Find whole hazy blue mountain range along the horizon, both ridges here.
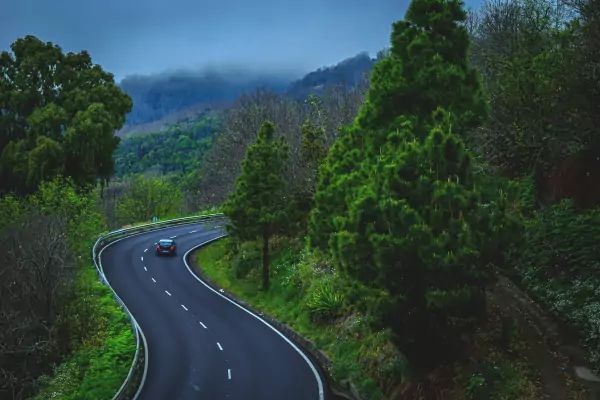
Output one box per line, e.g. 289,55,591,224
120,52,375,126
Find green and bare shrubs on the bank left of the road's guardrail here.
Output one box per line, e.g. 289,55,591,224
0,179,135,400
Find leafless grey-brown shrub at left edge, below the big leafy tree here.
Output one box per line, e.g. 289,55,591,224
0,215,74,399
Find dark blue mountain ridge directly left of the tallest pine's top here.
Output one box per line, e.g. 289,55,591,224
287,53,376,99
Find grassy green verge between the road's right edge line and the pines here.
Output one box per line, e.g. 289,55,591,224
194,239,384,400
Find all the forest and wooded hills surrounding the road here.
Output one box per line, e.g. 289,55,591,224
0,0,600,400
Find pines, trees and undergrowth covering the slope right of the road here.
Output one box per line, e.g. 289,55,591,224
209,0,600,399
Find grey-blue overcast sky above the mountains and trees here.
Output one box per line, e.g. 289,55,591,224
0,0,479,79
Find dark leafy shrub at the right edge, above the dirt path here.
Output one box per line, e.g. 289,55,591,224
510,201,600,365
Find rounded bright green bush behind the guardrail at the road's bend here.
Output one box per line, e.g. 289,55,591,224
115,175,183,224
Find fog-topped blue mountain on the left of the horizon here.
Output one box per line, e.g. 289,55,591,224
119,70,291,126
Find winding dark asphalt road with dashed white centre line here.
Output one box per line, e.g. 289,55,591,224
100,224,323,400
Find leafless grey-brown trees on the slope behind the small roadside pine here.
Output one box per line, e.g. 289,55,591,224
194,84,366,207
